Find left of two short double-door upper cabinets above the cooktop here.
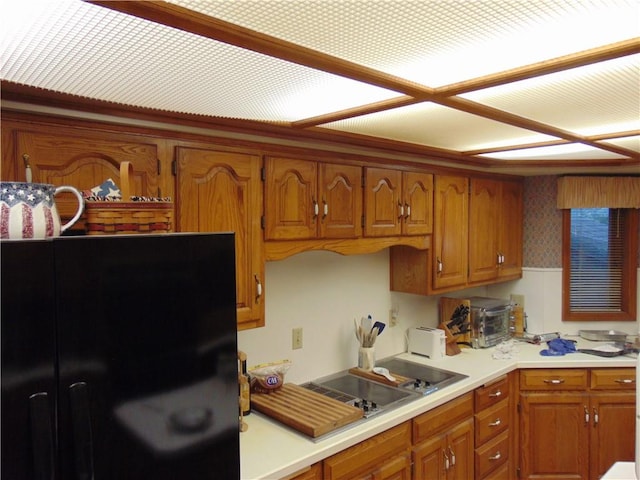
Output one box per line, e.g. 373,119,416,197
264,157,362,240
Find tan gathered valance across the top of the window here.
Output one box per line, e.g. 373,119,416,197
557,176,640,208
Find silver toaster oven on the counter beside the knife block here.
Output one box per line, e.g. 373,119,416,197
469,297,513,348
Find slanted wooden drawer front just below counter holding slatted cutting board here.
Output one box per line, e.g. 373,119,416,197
323,422,411,480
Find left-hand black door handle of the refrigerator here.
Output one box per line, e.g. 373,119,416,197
29,392,54,480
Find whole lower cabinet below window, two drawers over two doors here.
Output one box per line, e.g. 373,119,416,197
519,368,635,480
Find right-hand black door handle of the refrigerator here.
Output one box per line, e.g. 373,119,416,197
69,382,94,480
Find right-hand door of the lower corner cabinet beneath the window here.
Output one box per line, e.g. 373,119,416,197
591,392,636,479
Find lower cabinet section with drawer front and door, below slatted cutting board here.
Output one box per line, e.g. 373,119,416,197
323,422,411,480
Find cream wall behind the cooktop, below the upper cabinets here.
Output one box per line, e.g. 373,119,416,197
238,250,486,383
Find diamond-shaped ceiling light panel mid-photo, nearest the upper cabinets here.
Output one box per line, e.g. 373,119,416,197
321,103,555,151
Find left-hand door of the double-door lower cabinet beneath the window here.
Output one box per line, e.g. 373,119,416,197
520,391,590,480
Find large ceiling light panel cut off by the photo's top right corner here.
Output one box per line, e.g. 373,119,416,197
170,0,640,87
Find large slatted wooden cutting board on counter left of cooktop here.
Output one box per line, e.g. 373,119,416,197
251,383,363,438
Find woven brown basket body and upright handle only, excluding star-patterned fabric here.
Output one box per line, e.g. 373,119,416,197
85,162,173,235
